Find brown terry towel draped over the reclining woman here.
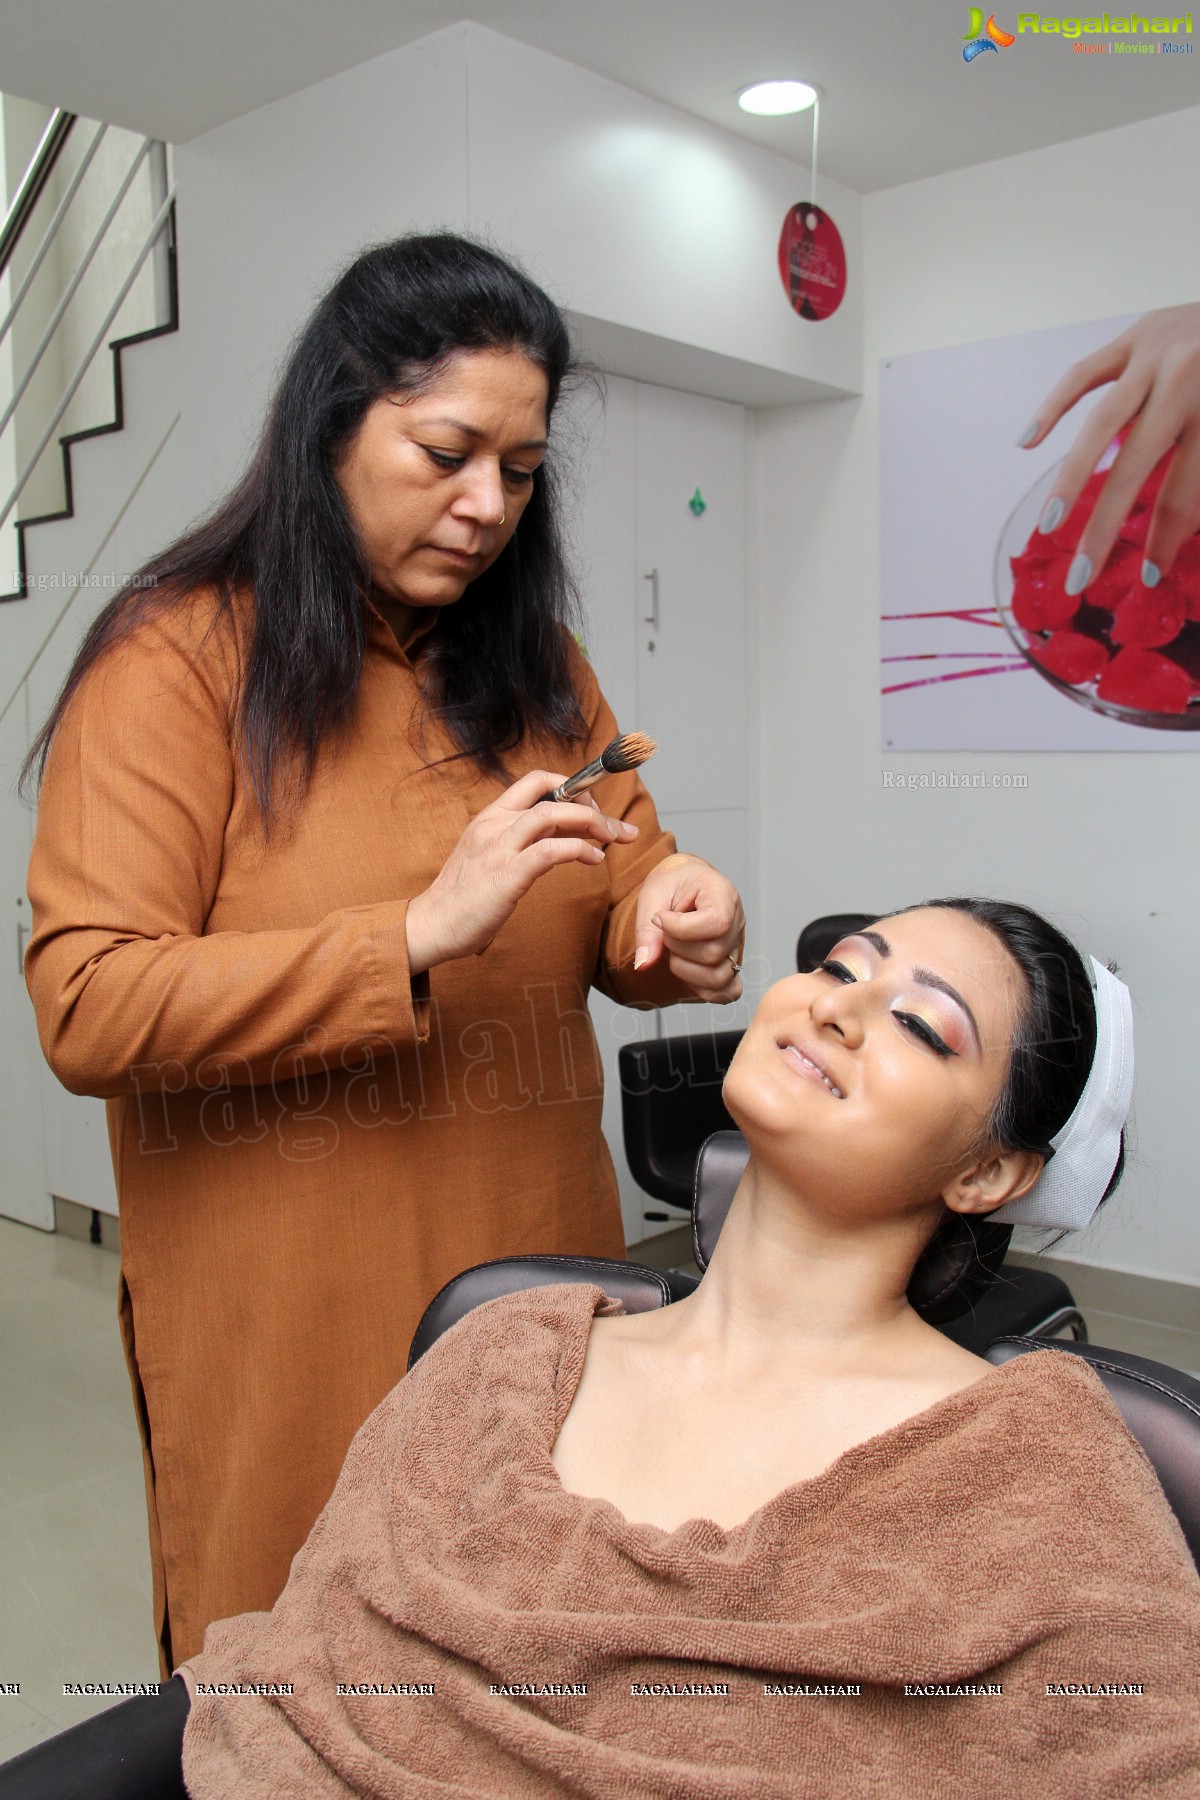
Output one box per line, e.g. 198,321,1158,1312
184,1287,1200,1800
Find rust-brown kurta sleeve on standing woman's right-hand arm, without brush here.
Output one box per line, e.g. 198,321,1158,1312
572,644,712,1008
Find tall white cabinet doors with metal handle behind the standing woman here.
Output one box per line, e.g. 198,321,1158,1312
569,378,752,1244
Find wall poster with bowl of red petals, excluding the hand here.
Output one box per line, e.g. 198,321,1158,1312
880,315,1200,751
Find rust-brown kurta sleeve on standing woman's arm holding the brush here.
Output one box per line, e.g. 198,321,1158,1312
25,599,428,1098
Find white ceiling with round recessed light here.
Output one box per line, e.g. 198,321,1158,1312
0,0,1200,190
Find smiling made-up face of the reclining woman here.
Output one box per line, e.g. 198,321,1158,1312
725,907,1024,1217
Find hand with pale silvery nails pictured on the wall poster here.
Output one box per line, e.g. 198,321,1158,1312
1020,306,1200,594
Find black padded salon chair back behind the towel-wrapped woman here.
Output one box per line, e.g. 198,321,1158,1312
408,1132,1200,1562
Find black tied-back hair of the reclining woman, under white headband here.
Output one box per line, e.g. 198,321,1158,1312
889,898,1124,1323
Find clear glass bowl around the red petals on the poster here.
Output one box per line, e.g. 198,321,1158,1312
995,463,1200,731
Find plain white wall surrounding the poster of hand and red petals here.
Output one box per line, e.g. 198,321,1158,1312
750,108,1200,1298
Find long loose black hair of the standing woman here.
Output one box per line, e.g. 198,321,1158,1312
22,232,585,824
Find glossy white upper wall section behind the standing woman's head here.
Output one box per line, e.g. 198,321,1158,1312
176,25,862,511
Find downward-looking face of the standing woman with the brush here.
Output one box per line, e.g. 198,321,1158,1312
335,349,549,607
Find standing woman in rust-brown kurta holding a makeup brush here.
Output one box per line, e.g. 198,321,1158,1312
27,236,743,1674
